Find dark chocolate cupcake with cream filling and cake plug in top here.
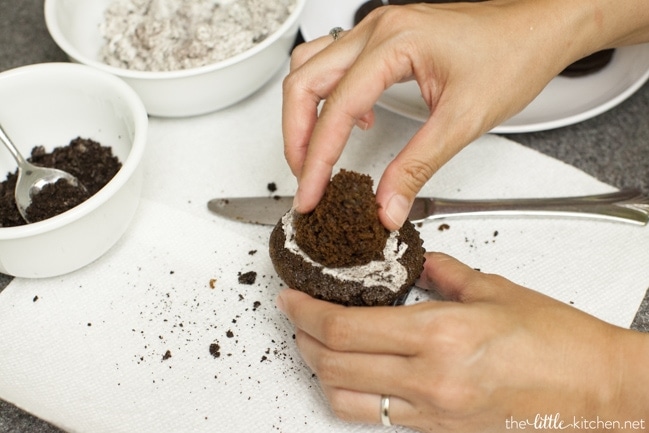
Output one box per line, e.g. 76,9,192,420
270,170,424,306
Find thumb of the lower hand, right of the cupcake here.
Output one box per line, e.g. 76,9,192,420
415,252,504,302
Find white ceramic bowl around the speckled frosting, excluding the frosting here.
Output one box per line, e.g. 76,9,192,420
45,0,307,117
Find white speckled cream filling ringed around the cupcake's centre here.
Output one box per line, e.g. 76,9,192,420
282,211,408,293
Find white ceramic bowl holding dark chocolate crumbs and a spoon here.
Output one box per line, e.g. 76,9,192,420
0,63,148,278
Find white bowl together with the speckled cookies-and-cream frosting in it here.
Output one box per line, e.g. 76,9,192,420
45,0,306,117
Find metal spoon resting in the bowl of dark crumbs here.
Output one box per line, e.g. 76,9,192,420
0,121,87,223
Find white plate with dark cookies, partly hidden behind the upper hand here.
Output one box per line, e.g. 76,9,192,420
301,0,649,134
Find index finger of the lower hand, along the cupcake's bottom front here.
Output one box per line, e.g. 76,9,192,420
277,289,430,356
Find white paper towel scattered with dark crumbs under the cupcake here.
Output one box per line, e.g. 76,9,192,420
0,64,649,433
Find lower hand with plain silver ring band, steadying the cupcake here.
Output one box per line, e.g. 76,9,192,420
278,253,649,433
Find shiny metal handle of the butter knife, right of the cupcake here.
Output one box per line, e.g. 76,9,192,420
410,189,649,225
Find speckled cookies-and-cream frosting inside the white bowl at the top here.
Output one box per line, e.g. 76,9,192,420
100,0,296,71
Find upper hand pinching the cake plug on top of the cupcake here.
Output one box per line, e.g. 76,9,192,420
283,0,594,229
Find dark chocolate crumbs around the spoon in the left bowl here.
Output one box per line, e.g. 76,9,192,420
0,137,122,227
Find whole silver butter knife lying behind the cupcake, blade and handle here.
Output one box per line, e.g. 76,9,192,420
207,189,649,225
